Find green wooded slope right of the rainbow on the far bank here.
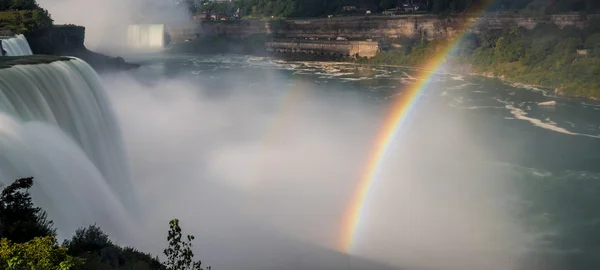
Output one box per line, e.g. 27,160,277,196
458,20,600,98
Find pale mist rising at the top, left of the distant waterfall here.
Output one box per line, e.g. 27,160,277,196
37,0,190,51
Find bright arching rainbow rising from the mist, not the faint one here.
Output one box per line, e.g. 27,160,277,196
339,1,492,253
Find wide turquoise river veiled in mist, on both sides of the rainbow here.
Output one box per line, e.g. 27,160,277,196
104,55,600,269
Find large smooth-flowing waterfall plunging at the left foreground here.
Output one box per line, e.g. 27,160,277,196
0,58,135,238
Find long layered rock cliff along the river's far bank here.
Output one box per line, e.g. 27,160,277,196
169,13,600,42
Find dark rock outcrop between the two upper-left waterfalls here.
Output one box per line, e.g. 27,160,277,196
27,25,139,71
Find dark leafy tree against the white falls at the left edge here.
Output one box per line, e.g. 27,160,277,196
0,177,56,243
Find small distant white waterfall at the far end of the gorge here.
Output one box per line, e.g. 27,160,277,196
127,24,165,49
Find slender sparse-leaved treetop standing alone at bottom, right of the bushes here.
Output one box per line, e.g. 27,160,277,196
164,219,211,270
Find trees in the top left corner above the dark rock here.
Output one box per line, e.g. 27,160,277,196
0,0,53,35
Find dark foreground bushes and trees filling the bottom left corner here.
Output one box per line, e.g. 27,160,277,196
0,178,210,270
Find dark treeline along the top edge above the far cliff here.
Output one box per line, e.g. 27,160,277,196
187,0,600,17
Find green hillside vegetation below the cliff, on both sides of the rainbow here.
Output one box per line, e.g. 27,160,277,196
358,22,600,98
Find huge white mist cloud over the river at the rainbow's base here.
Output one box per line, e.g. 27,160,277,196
94,63,535,270
